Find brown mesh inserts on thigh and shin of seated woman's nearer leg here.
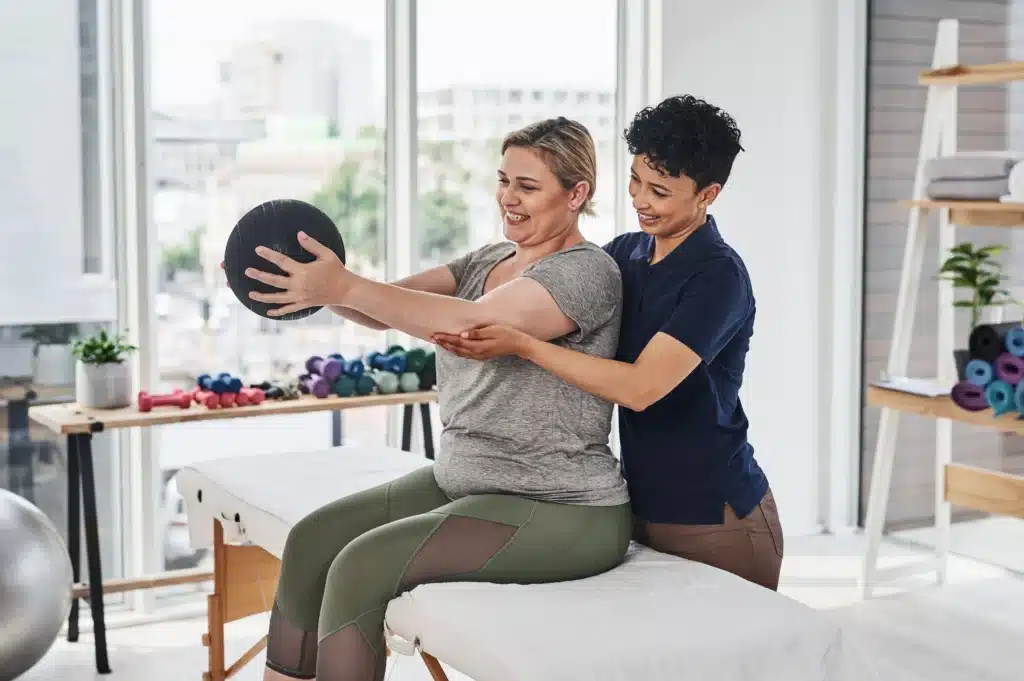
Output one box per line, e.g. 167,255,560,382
316,515,517,681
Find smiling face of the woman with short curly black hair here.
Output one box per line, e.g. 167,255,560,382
630,155,722,238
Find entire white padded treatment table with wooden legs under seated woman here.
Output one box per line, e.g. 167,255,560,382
177,446,877,681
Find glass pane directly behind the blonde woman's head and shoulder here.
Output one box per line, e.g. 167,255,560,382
414,0,622,268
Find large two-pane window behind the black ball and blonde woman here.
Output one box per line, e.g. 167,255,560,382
111,0,647,605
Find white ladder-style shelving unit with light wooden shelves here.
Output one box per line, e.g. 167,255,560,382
860,19,1024,598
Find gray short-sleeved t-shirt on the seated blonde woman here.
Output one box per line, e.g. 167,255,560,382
434,242,629,506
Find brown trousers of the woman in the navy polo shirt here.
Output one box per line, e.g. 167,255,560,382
633,490,782,591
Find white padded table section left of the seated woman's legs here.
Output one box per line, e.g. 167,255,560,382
176,446,430,558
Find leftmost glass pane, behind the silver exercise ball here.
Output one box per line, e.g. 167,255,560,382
0,0,124,610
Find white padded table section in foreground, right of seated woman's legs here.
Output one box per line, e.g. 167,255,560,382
387,544,878,681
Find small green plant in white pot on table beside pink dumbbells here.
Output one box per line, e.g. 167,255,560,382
74,331,138,409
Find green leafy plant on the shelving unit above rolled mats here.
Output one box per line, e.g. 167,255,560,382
939,242,1017,329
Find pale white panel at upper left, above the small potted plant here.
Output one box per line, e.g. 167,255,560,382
0,0,115,325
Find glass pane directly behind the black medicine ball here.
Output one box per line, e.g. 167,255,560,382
150,0,387,591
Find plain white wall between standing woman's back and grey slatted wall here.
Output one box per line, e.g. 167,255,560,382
660,0,860,535
